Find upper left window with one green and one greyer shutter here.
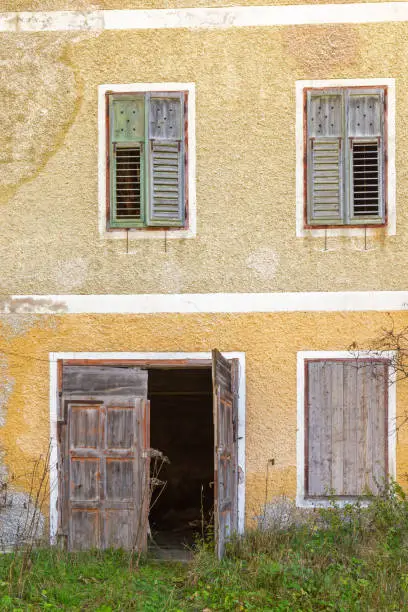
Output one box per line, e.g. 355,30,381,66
106,91,188,229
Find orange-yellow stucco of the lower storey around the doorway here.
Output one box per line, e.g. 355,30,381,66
0,312,408,521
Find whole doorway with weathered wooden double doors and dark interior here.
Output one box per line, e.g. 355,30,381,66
50,350,241,556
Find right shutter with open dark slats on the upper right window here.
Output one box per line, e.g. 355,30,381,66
346,89,385,224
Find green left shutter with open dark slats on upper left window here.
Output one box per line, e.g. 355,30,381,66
109,95,145,228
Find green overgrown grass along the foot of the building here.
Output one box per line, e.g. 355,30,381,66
0,485,408,612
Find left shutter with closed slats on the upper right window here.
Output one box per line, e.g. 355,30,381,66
307,91,344,225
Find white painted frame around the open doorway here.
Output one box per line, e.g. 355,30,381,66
49,352,246,544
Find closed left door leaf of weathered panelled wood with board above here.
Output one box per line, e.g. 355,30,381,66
59,368,149,550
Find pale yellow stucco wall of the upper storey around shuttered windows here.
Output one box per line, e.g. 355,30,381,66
0,23,408,294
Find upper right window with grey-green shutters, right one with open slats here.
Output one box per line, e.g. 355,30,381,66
304,87,387,227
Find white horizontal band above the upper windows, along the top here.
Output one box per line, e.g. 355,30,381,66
0,2,408,32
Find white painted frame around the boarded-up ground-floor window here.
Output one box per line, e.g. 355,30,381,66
296,351,397,508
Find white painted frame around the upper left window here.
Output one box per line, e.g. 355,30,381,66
98,83,197,240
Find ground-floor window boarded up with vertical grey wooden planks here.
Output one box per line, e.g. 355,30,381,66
304,358,389,499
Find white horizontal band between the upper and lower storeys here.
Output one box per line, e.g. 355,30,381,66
0,291,408,314
